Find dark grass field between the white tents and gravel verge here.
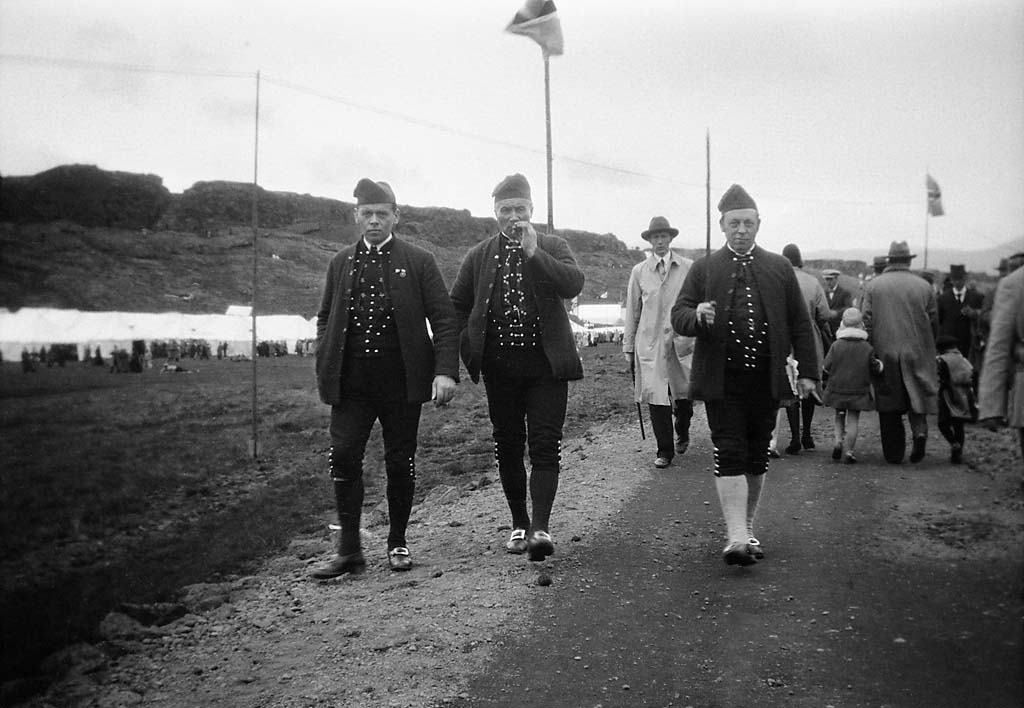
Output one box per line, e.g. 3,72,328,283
0,344,635,680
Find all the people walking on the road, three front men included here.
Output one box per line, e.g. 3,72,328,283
303,174,1024,580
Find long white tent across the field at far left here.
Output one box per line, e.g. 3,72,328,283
0,307,316,361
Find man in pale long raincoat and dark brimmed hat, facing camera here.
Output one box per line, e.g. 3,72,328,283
623,216,693,468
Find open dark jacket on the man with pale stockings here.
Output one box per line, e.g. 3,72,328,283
672,246,820,401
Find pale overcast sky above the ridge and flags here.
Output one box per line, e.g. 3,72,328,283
0,0,1024,266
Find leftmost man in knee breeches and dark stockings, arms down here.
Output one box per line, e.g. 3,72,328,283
311,179,459,579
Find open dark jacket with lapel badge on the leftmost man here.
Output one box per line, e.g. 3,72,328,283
316,238,459,406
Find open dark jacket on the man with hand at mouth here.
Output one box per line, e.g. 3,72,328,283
452,234,584,383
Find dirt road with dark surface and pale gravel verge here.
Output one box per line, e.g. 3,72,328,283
22,413,1024,708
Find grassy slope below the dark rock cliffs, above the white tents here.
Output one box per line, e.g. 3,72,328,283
0,219,642,317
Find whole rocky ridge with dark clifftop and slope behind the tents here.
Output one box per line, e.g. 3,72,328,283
0,165,644,318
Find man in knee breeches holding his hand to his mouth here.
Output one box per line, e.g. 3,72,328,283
452,174,584,560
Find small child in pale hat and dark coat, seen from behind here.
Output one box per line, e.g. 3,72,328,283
823,307,882,464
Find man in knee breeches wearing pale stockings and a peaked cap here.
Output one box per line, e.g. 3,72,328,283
672,184,819,566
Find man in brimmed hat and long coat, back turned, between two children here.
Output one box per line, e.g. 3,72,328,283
861,241,939,464
